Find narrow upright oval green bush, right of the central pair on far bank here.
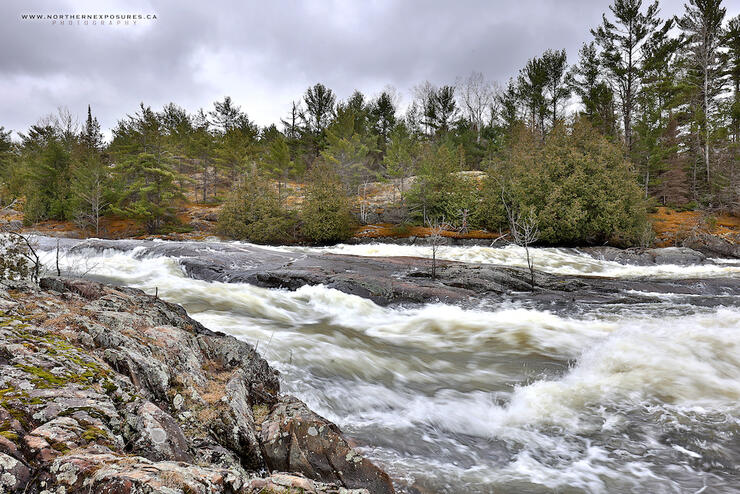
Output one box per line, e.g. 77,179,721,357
301,164,355,244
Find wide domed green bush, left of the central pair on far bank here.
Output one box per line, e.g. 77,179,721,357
218,174,298,245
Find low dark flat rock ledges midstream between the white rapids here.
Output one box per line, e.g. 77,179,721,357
72,240,740,310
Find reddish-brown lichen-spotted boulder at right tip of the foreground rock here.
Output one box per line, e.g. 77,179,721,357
260,397,394,494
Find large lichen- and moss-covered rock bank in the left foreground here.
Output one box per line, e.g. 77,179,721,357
0,278,394,494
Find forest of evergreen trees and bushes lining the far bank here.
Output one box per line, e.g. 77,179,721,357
0,0,740,246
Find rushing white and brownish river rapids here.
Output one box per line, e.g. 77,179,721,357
42,241,740,493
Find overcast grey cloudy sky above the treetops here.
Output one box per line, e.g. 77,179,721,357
0,0,740,138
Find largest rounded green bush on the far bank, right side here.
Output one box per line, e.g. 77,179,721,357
483,121,648,246
